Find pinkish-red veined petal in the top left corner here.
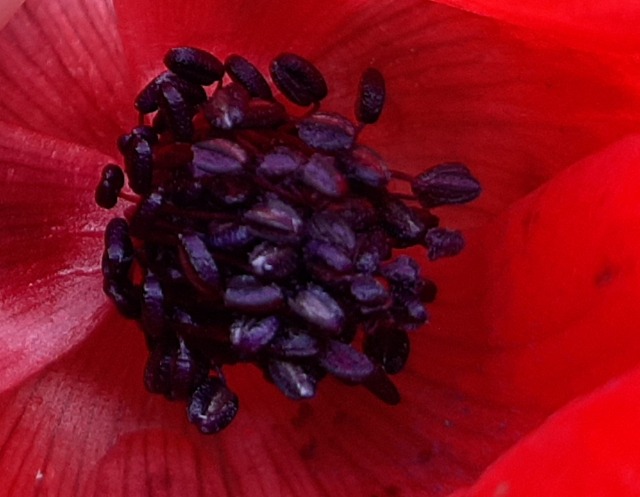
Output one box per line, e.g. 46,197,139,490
0,0,135,152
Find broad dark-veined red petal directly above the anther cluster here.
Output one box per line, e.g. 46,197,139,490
116,0,640,224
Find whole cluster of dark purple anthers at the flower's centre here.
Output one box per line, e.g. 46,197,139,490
95,47,480,433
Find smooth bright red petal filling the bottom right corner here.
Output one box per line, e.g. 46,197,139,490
451,369,640,497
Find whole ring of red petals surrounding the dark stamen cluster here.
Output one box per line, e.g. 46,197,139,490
0,0,640,496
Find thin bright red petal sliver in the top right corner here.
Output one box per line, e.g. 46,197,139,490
437,0,640,53
